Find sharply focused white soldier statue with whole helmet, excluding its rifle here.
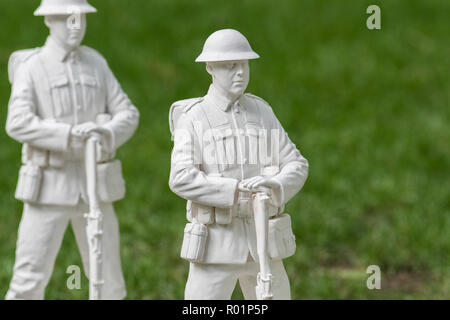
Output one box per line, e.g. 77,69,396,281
169,29,308,299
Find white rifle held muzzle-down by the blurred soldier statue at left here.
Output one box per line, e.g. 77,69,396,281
84,134,103,300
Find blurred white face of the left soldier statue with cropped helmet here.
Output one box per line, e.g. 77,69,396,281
45,14,87,49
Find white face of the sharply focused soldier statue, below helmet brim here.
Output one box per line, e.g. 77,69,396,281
206,60,250,98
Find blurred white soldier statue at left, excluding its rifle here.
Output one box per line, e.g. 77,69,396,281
6,0,139,299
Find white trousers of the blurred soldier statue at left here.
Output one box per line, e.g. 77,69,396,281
5,201,126,300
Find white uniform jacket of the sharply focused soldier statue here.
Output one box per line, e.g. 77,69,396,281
169,85,308,263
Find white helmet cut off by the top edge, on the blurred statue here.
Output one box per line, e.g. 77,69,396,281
34,0,97,16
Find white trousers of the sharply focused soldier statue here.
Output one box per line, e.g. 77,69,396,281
184,258,291,300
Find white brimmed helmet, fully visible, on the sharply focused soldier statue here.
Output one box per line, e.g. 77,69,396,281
195,29,259,62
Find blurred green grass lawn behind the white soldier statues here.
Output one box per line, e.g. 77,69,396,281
0,0,450,299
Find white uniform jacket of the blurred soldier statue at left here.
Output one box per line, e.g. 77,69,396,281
6,37,139,205
